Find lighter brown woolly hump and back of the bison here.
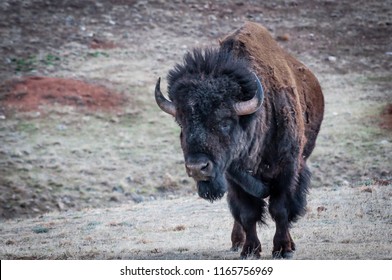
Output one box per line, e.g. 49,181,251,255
220,22,324,159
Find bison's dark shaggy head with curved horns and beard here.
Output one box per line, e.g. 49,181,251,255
155,50,264,201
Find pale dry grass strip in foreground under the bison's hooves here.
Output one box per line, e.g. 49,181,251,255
0,184,392,259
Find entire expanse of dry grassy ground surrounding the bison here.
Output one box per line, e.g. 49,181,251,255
0,0,392,259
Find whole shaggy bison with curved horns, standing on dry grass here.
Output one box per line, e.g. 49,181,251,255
155,22,324,258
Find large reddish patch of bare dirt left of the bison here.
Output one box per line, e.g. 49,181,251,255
0,77,125,111
